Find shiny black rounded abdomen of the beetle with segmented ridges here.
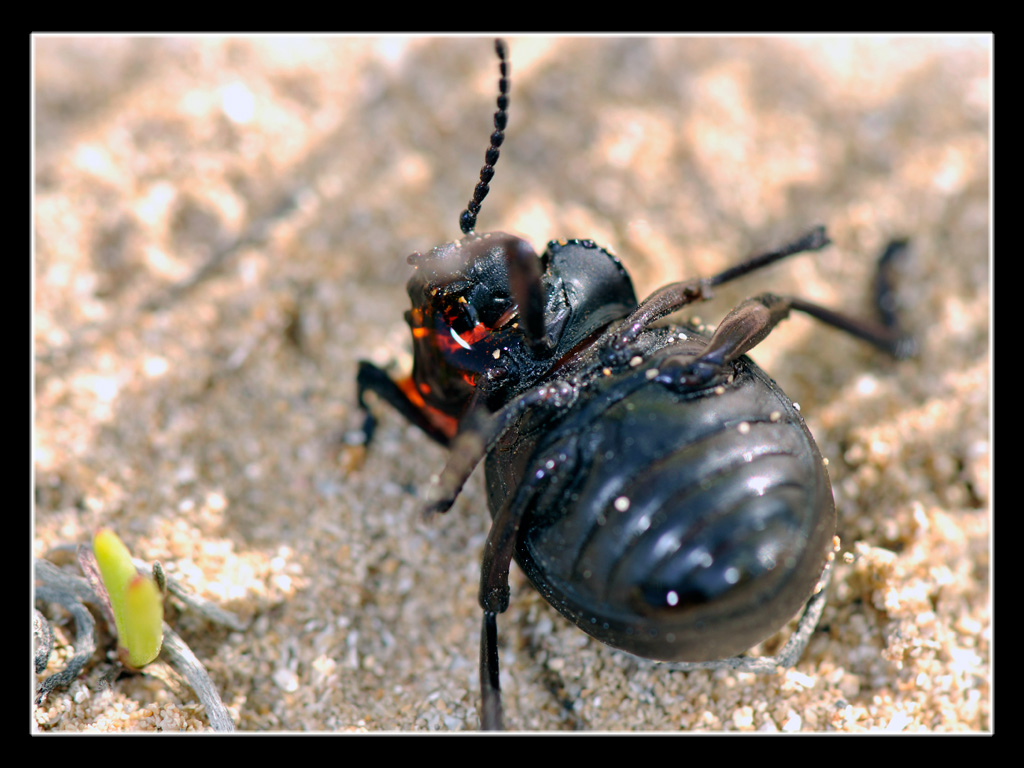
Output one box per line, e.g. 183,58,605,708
488,332,836,660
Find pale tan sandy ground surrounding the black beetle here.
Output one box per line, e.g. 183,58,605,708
33,37,992,732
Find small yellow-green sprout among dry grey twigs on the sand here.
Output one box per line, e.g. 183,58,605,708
92,528,164,670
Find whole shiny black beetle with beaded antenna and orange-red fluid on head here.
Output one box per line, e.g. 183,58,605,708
357,40,914,729
